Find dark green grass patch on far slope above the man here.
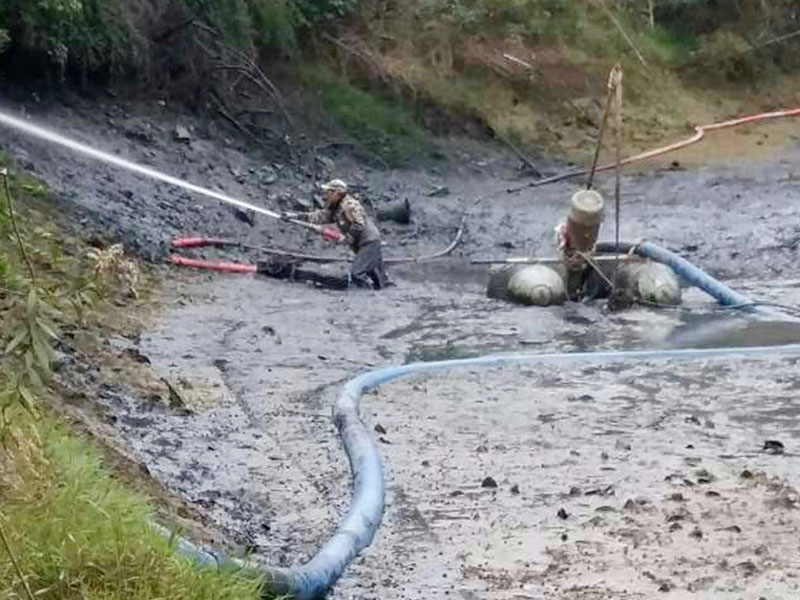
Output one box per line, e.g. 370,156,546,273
300,65,426,165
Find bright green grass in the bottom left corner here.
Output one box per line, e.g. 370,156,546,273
0,412,259,600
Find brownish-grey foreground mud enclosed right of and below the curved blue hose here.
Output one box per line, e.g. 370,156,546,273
364,359,800,599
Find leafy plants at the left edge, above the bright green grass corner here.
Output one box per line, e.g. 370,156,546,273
0,168,139,438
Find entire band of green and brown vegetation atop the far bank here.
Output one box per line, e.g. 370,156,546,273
0,0,800,156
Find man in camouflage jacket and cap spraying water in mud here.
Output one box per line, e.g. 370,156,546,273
283,179,390,290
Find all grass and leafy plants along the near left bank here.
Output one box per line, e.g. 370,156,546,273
0,163,259,600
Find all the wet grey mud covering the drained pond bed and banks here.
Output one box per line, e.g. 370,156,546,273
0,94,800,600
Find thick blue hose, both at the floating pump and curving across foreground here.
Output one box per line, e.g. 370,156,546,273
164,243,800,600
